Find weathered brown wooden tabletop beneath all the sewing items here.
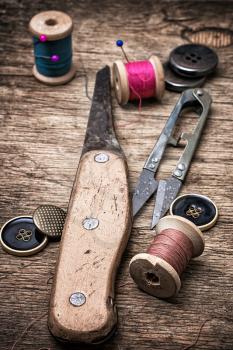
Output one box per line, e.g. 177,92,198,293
0,0,233,350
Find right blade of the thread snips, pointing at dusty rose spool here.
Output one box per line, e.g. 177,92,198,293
151,176,182,229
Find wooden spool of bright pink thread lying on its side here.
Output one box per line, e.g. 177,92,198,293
113,56,165,105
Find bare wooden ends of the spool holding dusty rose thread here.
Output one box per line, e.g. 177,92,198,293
129,215,205,298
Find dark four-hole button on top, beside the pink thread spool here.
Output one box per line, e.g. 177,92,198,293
169,44,218,77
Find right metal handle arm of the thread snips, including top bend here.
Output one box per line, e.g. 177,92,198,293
172,88,212,181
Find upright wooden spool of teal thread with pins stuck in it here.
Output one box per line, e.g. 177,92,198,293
29,11,76,85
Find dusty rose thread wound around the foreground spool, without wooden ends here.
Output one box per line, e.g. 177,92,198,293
147,229,193,276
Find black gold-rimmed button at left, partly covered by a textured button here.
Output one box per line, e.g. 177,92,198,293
0,216,48,256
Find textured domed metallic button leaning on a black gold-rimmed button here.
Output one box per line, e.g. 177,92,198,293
33,205,66,239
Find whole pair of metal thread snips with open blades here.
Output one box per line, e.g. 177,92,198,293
133,88,212,229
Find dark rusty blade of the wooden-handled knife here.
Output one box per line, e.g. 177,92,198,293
82,66,122,154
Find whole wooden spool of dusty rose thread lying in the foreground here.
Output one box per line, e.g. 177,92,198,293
129,215,205,298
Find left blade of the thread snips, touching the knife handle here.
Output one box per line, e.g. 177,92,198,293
133,169,158,216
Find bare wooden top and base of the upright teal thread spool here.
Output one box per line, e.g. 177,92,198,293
29,11,76,85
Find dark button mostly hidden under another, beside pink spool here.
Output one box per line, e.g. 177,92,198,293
164,62,206,92
